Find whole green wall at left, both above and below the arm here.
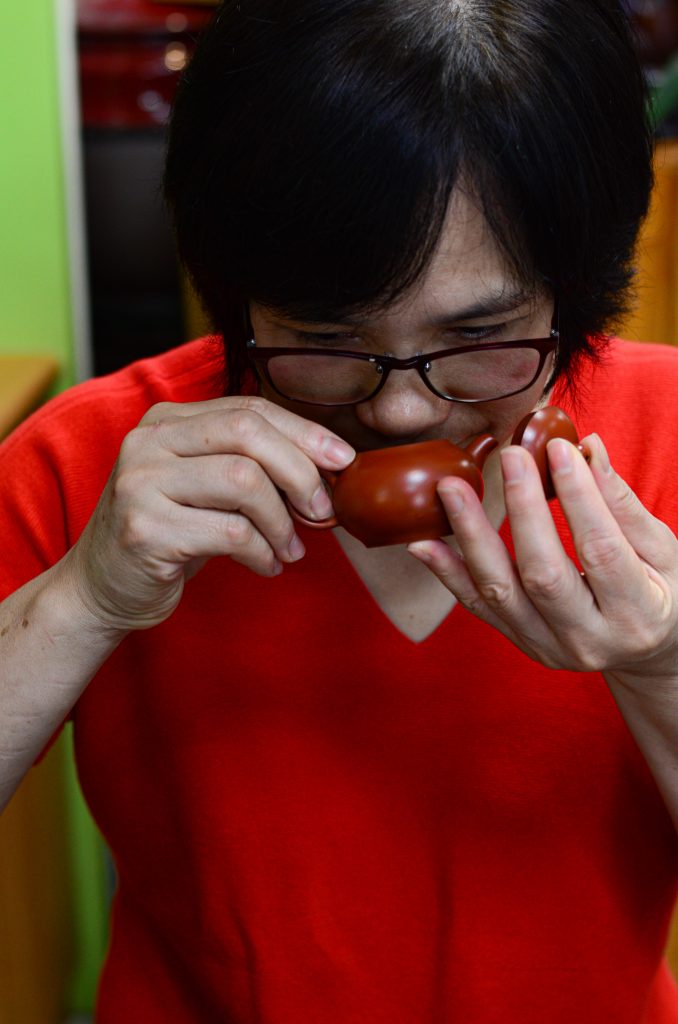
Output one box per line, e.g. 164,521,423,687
0,0,108,1011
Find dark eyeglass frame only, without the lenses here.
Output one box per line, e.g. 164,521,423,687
247,309,560,407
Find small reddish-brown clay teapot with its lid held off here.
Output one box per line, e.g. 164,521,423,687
290,406,582,548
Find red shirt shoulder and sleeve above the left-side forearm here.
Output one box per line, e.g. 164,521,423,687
0,338,226,580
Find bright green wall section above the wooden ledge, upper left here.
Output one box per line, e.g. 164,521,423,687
0,0,74,386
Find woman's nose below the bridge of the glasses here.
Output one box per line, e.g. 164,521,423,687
355,370,454,439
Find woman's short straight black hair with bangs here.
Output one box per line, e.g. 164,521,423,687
165,0,652,391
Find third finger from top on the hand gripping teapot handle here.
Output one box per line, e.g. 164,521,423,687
158,455,304,562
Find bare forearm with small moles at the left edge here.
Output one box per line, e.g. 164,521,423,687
0,556,124,810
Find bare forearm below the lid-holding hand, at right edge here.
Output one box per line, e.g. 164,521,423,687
604,672,678,830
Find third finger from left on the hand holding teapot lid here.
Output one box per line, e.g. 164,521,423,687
501,445,600,634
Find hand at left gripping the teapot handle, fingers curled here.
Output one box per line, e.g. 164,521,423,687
65,397,354,632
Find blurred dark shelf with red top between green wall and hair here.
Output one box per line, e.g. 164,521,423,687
78,0,213,374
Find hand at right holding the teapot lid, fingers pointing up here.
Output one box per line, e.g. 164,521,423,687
409,434,678,685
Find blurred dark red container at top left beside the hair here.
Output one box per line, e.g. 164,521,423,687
78,0,214,128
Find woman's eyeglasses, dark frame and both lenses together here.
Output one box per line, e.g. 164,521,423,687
247,312,559,406
